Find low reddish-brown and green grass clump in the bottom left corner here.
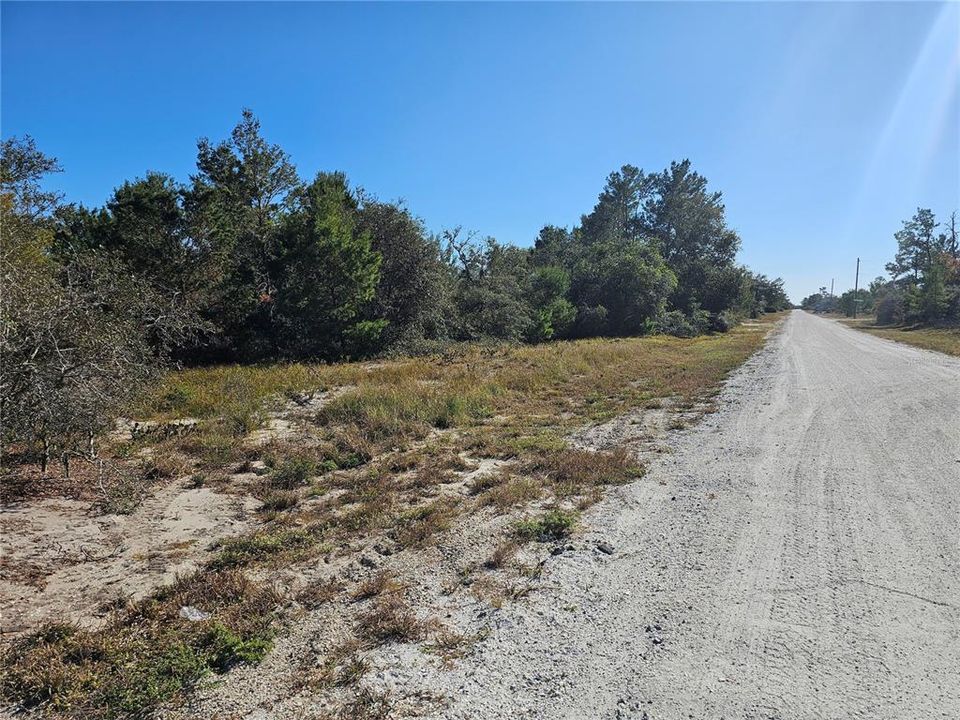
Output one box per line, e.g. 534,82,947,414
2,571,278,718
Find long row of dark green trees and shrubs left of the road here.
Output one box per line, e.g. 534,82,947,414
0,111,789,472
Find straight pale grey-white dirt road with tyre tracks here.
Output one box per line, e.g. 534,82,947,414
420,311,960,720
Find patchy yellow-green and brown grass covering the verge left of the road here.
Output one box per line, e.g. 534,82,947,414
2,317,777,718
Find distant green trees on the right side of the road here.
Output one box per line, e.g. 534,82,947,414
801,208,960,325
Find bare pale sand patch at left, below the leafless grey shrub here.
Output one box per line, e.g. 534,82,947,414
0,480,260,638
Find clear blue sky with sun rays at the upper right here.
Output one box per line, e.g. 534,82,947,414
0,2,960,301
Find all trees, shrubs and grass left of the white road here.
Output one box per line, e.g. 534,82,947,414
0,112,789,718
